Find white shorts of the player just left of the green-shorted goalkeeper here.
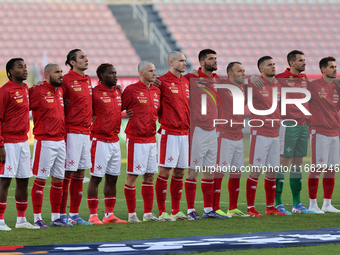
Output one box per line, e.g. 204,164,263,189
249,130,280,169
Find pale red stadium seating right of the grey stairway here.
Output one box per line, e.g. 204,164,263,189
154,4,340,75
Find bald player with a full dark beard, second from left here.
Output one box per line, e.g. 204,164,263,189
29,64,72,228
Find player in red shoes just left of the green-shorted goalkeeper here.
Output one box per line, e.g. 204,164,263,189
246,56,286,217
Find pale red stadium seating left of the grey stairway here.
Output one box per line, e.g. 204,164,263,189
0,2,140,76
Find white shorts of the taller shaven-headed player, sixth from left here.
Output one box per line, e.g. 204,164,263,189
158,129,189,168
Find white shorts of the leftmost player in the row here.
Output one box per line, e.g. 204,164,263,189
0,141,33,179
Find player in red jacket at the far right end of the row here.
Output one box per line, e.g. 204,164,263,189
308,57,340,214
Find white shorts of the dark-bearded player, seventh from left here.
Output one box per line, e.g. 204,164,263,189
190,127,217,169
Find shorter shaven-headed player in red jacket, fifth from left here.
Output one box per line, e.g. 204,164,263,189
122,61,161,222
